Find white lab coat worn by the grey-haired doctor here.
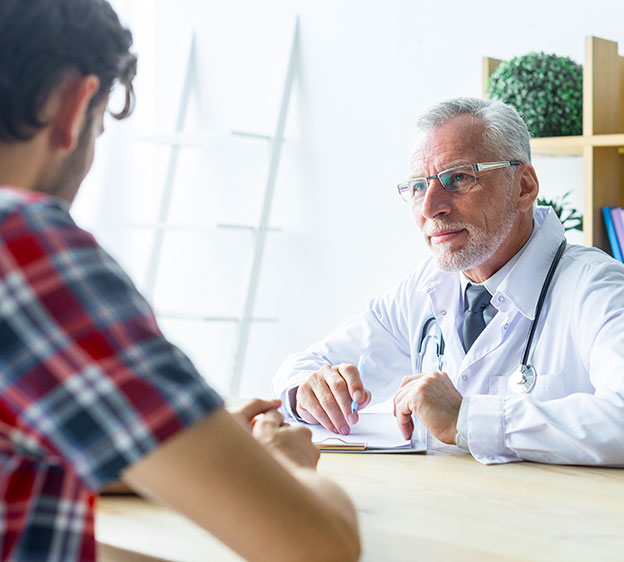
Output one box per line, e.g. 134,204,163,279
273,207,624,466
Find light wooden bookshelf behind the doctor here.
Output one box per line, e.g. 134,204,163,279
483,36,624,252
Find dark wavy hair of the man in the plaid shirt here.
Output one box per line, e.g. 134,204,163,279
0,0,136,142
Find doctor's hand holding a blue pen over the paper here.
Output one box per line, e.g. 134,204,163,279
296,363,371,435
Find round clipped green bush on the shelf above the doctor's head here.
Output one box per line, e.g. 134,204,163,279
486,52,583,137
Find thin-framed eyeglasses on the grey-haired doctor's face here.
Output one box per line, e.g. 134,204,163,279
397,160,522,202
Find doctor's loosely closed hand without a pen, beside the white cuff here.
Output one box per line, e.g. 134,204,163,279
394,372,462,445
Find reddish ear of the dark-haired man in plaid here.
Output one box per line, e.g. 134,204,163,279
50,74,100,151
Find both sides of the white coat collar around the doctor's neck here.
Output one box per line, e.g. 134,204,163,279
416,207,564,320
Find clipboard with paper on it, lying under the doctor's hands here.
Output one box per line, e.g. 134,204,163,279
307,412,427,453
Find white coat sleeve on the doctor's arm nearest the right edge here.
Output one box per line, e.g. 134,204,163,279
467,255,624,466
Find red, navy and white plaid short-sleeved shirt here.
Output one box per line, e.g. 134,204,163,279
0,187,222,562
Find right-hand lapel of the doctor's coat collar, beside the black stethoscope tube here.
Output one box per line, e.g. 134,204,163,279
494,207,565,320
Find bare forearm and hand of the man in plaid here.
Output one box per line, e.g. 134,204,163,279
123,409,360,562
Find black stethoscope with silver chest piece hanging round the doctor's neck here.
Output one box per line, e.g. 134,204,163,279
416,239,566,394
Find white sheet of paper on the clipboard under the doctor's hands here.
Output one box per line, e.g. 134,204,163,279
307,412,426,449
